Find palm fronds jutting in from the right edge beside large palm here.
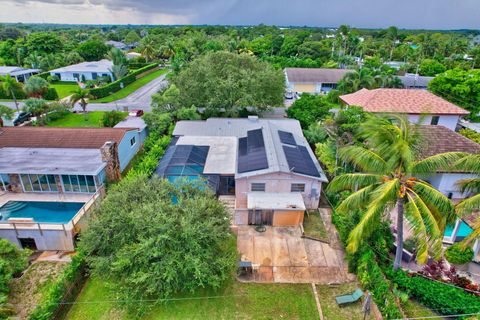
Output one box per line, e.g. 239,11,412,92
456,154,480,245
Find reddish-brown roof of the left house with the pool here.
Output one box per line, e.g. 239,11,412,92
0,127,136,149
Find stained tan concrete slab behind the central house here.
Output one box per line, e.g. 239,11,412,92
237,226,352,284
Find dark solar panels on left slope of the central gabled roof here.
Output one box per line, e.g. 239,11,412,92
238,129,268,173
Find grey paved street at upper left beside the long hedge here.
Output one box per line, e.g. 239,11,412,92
0,75,167,111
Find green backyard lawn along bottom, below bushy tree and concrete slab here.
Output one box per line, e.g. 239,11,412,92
66,278,318,320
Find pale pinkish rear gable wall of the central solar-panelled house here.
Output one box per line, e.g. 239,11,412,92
235,173,322,209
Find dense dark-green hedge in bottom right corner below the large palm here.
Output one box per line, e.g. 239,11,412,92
385,270,480,315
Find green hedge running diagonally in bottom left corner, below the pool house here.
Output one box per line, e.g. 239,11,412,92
29,252,87,320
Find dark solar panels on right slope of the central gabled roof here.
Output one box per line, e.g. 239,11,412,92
278,131,320,177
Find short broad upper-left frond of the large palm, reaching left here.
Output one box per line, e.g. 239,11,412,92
339,146,386,173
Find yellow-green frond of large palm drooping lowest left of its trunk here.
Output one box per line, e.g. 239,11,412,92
347,179,400,253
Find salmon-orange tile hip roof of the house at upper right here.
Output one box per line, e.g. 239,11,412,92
340,89,469,115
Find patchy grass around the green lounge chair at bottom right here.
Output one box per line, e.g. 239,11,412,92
317,283,375,320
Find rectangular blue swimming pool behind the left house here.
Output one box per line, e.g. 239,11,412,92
0,201,84,223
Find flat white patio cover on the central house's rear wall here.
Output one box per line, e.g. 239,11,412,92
247,192,306,211
